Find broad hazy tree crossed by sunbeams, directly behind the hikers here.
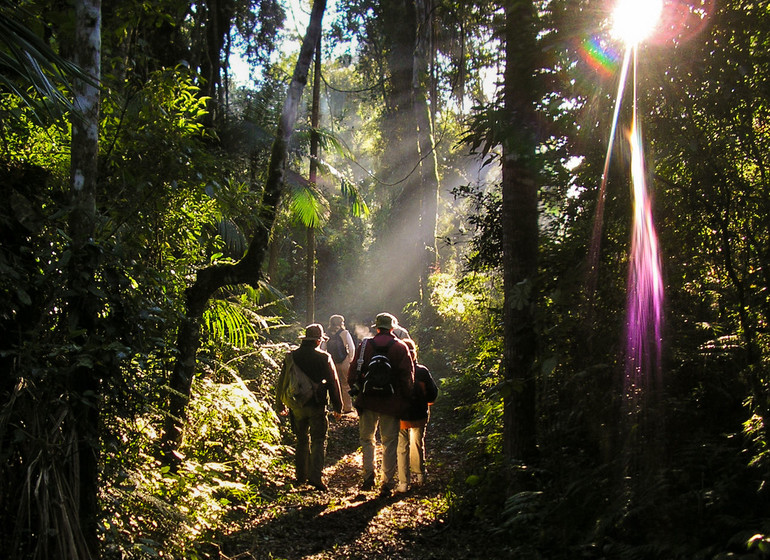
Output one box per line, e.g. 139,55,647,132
330,0,492,311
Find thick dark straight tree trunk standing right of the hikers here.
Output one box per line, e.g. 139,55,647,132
502,0,538,464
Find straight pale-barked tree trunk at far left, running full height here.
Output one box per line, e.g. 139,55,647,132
67,0,104,558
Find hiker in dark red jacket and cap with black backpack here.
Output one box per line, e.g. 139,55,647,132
348,313,414,496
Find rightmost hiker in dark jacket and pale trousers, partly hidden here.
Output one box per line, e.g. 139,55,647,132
398,338,438,492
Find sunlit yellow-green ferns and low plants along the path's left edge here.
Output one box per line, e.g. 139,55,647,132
103,370,279,558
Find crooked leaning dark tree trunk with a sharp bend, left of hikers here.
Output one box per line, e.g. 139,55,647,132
161,0,326,465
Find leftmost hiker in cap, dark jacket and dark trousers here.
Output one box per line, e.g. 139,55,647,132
275,323,342,492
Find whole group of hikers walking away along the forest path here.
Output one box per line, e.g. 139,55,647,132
275,313,438,496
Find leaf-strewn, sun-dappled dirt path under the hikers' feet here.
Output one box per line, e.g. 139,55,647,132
214,390,502,560
